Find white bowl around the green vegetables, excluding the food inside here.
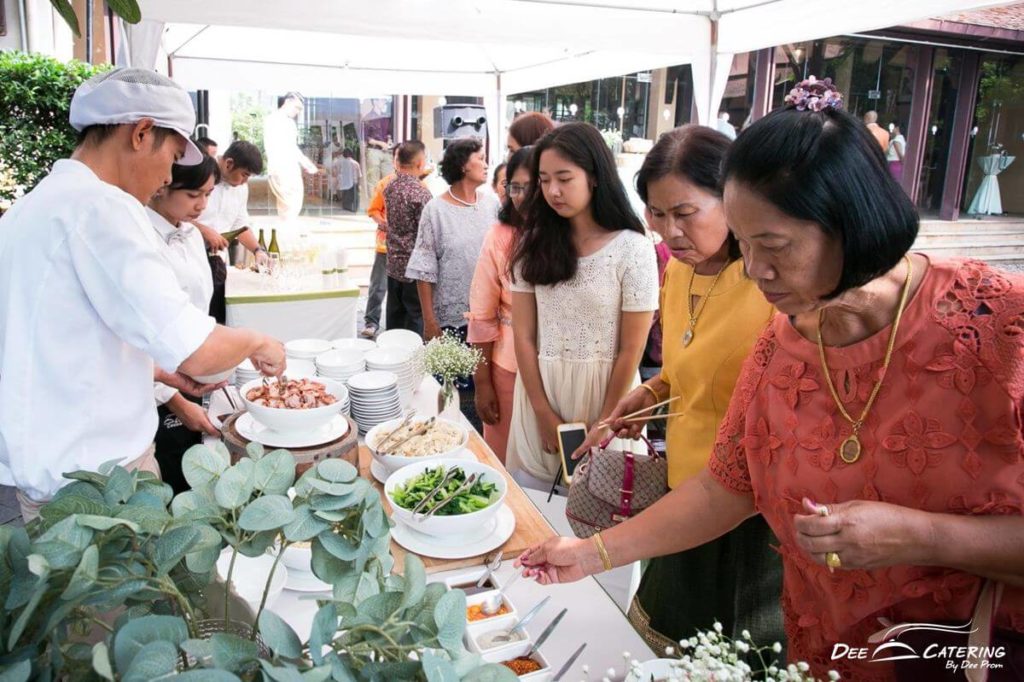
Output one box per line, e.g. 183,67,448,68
384,458,508,538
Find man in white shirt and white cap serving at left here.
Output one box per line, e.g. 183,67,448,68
0,69,285,522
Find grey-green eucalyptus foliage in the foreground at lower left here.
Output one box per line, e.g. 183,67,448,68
0,444,515,682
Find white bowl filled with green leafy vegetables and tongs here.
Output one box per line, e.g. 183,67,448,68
384,459,508,538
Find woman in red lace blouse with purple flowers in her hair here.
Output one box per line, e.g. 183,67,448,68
520,76,1024,681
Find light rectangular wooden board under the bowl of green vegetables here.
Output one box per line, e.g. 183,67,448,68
359,432,555,573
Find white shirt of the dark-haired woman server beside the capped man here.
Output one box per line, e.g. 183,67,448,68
145,207,213,404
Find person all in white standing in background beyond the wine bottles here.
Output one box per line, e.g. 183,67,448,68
263,92,316,232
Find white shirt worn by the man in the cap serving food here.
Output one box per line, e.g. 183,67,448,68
0,160,214,501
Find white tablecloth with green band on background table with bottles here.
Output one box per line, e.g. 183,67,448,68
226,267,359,341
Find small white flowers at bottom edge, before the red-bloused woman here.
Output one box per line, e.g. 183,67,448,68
623,623,840,682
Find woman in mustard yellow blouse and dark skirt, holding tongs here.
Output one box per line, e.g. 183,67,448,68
582,125,783,651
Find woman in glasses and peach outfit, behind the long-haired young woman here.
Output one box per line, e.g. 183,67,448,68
466,146,532,464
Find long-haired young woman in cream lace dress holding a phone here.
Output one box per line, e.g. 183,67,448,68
507,123,657,484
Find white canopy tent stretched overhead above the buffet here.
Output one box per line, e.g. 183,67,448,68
134,0,1008,158
